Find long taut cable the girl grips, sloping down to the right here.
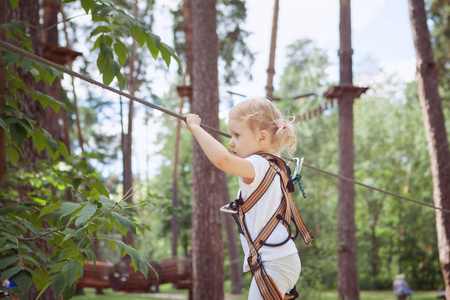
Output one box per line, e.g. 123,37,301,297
0,40,450,213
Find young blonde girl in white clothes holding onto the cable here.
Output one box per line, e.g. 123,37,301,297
186,98,312,300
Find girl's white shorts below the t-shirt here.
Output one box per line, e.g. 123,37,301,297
248,253,302,300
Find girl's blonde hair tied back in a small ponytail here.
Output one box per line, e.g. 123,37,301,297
228,98,297,154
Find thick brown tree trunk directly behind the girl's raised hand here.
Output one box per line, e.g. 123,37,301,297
191,0,224,300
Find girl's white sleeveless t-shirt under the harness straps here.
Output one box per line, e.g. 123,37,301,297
238,155,297,272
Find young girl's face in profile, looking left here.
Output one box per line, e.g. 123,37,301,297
228,119,268,158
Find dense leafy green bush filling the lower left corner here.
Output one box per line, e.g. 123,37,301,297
0,159,148,299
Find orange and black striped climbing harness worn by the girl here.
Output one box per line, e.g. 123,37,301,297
221,153,313,300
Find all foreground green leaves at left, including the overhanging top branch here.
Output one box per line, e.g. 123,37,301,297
0,0,179,299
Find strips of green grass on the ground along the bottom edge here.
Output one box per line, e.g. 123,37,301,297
73,284,438,300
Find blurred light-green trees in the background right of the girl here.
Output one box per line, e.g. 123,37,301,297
278,41,442,299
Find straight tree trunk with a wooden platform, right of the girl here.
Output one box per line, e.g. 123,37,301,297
337,0,359,300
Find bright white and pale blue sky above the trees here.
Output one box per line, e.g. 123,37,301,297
156,0,415,101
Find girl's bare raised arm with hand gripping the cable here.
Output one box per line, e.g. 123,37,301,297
185,114,255,182
